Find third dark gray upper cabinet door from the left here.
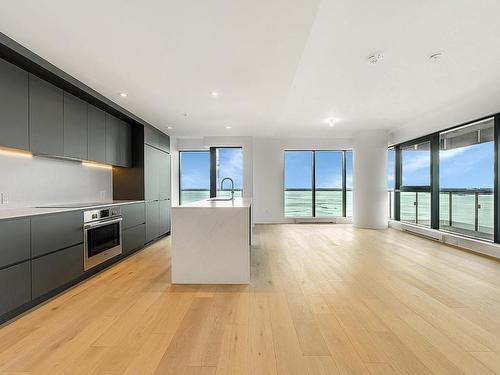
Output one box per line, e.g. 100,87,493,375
64,92,88,160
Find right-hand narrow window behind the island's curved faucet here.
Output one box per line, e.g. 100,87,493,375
215,147,243,198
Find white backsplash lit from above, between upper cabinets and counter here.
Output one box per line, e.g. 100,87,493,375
0,153,113,210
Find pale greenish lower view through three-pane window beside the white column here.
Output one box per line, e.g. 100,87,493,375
285,188,352,217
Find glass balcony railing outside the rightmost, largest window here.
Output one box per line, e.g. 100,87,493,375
439,189,494,240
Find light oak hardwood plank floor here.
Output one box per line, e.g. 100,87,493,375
0,224,500,375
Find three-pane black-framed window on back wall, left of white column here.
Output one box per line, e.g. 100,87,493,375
284,150,352,217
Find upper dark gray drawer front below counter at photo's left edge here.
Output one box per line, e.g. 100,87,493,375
0,217,31,268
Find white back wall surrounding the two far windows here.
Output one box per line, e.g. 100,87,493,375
172,137,351,223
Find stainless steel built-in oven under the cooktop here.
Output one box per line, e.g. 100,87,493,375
83,207,122,271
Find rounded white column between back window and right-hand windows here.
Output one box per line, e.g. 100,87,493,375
352,130,388,229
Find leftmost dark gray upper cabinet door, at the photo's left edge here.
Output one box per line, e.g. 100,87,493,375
0,59,30,150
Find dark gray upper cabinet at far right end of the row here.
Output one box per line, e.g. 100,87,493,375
106,114,132,167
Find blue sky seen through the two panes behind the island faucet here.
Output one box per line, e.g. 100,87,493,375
181,148,243,190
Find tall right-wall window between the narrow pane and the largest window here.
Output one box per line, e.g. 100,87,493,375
400,141,431,226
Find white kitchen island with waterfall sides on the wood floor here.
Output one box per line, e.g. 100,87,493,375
171,198,252,284
